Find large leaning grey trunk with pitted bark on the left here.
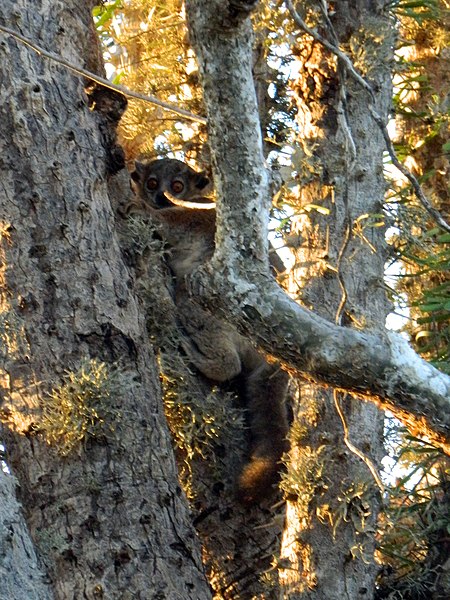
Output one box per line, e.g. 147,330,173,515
0,0,210,600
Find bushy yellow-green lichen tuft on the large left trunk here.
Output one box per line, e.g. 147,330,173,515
39,359,125,456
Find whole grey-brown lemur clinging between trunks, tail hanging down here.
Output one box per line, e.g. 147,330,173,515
131,159,288,502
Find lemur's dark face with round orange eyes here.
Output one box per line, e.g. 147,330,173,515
131,158,212,208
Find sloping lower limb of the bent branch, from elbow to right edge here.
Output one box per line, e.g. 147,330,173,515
191,267,450,454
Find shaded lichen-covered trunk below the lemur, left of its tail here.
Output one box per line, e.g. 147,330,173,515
139,258,284,600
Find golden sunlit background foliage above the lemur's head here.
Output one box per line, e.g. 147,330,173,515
94,0,209,168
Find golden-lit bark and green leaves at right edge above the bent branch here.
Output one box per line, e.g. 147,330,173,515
384,0,450,373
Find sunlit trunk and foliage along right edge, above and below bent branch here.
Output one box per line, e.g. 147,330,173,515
376,0,450,600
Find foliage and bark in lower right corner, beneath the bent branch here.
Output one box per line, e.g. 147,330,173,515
376,428,450,600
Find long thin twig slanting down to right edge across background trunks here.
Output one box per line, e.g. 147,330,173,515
286,0,450,232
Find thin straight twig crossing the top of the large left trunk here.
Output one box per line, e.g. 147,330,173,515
0,25,207,123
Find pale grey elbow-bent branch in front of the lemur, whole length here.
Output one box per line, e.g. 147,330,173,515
187,0,450,452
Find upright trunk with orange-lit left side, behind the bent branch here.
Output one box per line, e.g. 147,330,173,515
281,0,393,600
